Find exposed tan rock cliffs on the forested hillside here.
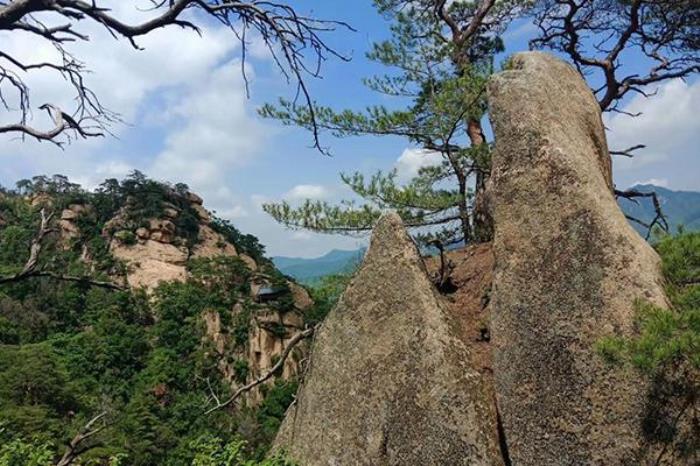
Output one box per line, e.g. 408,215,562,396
59,187,313,404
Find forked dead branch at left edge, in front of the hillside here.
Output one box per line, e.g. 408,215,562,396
0,209,125,291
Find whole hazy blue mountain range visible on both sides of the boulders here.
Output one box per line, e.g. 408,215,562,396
272,184,700,284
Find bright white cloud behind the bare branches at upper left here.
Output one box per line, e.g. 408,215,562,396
0,5,239,132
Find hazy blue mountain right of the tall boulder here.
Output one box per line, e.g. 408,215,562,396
618,184,700,235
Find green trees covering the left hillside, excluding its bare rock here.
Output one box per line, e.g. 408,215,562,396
0,176,318,466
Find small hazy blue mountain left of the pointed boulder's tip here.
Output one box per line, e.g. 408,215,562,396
272,248,365,284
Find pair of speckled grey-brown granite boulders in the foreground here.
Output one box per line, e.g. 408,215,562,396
276,53,691,466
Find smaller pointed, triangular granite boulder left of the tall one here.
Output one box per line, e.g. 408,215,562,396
276,214,503,466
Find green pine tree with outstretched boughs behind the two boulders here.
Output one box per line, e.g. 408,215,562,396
261,0,528,248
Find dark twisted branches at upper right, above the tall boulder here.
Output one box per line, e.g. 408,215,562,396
530,0,700,111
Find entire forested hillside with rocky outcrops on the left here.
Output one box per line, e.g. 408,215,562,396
0,172,324,465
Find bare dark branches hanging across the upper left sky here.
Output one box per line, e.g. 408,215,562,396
0,0,352,150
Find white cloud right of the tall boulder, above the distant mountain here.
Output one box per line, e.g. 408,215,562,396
604,79,700,189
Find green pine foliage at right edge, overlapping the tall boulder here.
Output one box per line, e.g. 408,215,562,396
598,231,700,456
